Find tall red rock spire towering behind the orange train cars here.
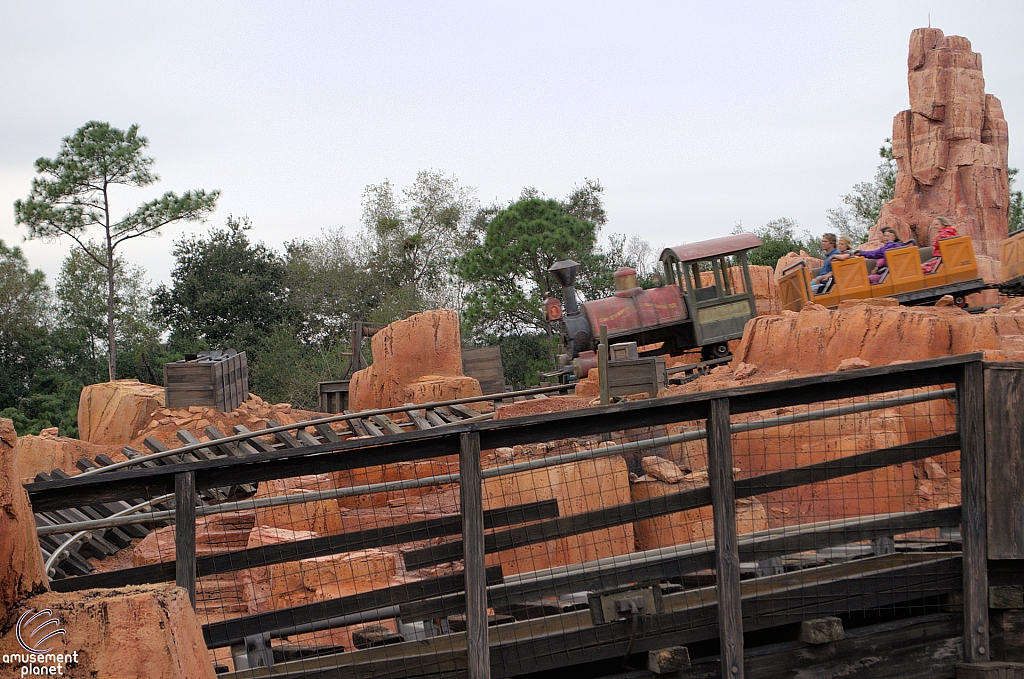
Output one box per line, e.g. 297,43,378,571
869,29,1010,258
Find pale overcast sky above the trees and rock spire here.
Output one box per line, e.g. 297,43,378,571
0,0,1024,284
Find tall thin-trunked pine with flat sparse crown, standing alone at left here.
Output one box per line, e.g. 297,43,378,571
14,121,219,380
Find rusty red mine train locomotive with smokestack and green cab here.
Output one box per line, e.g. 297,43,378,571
544,234,761,373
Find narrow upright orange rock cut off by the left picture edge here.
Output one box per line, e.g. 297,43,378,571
0,419,48,626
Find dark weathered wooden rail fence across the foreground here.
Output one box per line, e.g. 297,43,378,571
26,354,1007,679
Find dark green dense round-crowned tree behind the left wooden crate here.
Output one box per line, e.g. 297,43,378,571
154,217,292,351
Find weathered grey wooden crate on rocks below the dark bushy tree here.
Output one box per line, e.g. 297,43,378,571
164,349,249,413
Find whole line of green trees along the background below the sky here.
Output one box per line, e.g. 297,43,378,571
8,122,1019,435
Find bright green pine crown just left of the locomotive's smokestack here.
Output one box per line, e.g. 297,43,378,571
457,193,611,335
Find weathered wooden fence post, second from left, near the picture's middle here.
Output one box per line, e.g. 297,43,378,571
459,431,490,679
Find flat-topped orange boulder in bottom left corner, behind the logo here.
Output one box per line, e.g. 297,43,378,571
0,585,216,679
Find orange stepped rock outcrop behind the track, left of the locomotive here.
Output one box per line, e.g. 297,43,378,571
349,309,482,411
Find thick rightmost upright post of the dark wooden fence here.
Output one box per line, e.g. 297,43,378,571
956,360,990,663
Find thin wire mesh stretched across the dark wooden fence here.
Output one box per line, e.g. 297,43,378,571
25,356,983,677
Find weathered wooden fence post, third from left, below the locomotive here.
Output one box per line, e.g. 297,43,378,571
708,398,743,679
